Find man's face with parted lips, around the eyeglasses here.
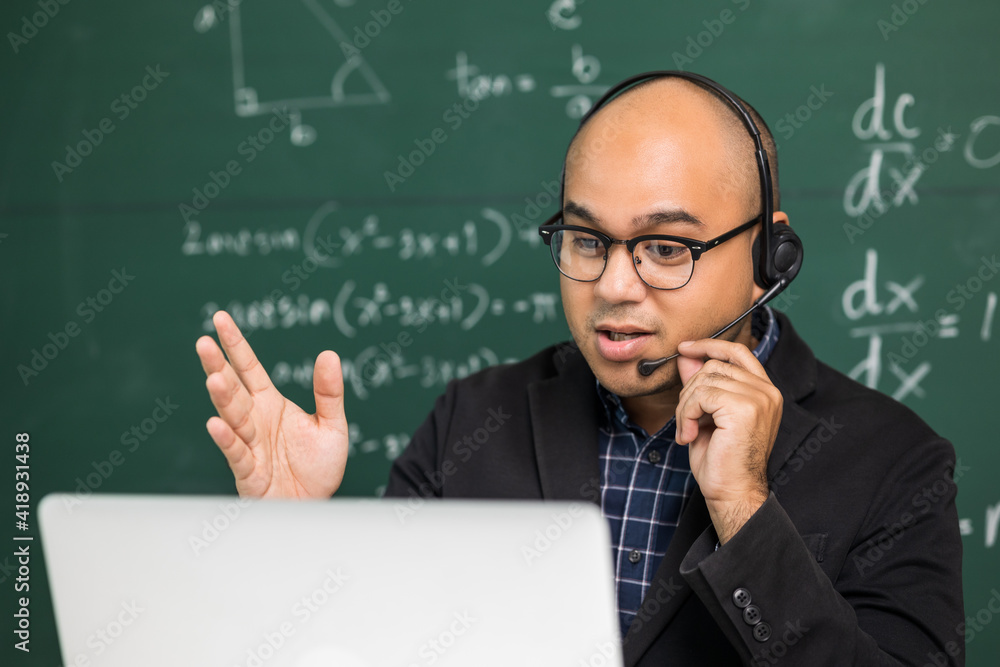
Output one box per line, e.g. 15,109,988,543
560,94,763,397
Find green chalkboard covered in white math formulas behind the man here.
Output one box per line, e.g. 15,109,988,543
0,0,1000,665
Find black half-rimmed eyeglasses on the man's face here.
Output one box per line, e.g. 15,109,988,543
538,213,763,290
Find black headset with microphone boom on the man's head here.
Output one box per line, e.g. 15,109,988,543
543,70,803,376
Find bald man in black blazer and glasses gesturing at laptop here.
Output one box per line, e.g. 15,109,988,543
197,77,964,666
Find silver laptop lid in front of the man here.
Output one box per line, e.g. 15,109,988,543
40,494,622,667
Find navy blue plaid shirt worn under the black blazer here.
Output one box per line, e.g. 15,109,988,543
597,307,780,637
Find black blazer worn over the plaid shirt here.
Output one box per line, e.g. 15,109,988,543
386,313,965,667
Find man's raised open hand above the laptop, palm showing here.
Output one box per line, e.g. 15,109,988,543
195,310,348,498
